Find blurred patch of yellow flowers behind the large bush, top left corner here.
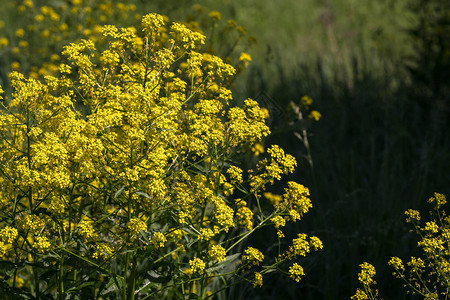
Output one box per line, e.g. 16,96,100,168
0,0,137,78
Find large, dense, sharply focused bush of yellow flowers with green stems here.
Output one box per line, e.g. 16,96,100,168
0,10,322,299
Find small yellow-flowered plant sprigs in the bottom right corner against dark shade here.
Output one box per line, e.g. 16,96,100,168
352,193,450,300
